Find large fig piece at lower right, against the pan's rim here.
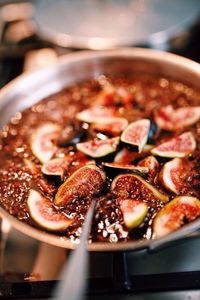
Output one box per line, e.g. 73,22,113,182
153,196,200,238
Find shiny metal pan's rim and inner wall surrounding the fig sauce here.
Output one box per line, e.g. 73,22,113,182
0,48,200,251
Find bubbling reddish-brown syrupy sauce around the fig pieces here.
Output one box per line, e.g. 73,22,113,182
0,74,200,242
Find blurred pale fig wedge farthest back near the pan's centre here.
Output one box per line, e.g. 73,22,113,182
76,105,116,123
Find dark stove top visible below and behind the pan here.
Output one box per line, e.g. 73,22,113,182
0,1,200,300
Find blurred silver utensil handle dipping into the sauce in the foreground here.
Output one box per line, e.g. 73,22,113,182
54,201,96,300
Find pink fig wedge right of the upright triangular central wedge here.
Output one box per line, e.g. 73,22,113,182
151,131,196,157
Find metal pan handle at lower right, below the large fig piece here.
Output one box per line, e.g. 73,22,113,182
148,224,200,252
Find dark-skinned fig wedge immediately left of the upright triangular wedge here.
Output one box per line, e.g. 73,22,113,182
76,137,119,158
